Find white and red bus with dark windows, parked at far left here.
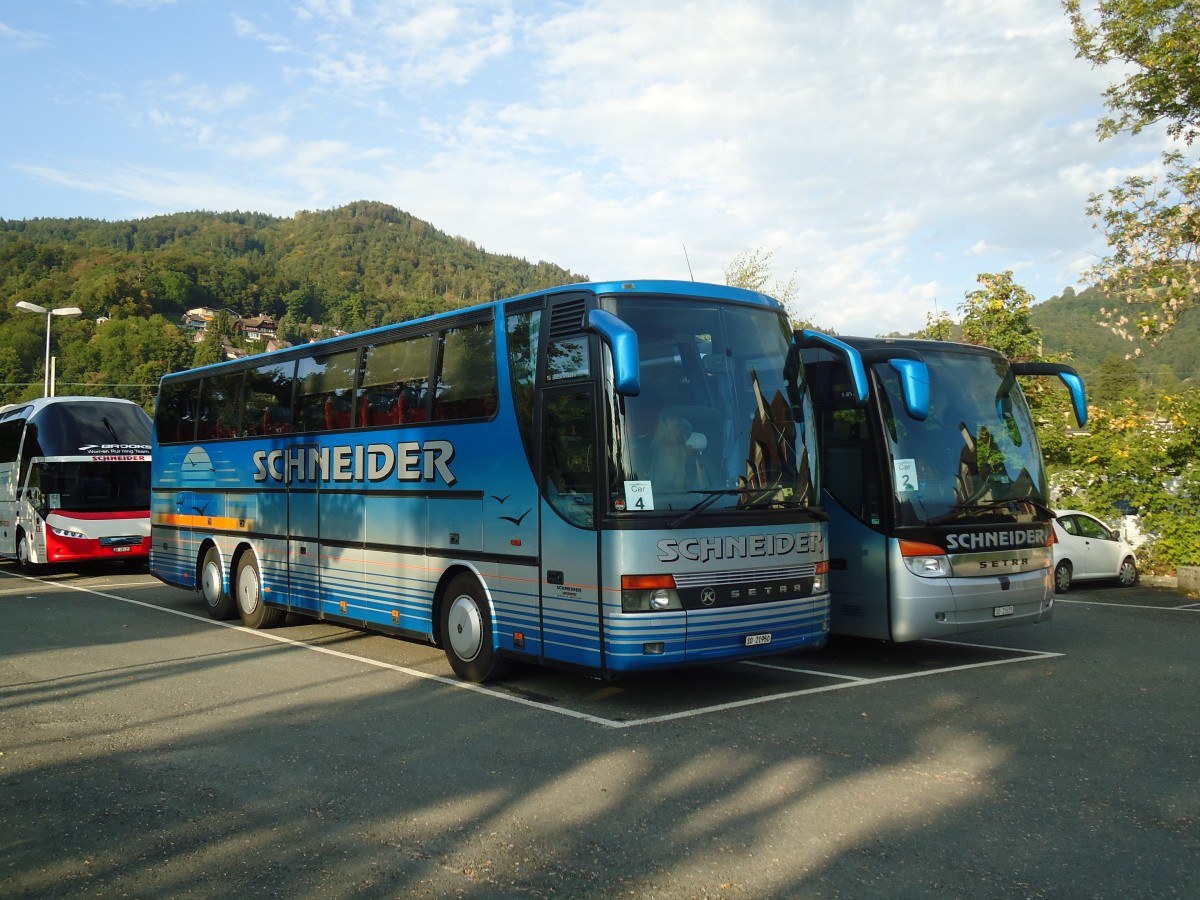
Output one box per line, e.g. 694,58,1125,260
0,397,151,571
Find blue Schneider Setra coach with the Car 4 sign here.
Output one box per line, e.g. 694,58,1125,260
150,281,865,682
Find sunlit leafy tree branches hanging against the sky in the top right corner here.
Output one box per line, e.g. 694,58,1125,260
1062,0,1200,338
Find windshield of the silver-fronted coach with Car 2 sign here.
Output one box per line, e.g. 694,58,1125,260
874,350,1048,524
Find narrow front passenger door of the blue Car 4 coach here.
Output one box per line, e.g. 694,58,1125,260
540,384,605,667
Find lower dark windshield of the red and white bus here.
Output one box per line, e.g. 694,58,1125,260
29,461,150,518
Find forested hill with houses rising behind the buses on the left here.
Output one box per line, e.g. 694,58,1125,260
0,202,584,402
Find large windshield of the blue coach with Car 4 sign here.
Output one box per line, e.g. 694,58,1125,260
602,295,818,512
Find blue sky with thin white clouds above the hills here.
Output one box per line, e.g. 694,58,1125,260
0,0,1165,335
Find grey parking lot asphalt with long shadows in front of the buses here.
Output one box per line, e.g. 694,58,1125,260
0,564,1200,898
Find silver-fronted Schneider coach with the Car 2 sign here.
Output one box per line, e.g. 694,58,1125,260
802,337,1087,641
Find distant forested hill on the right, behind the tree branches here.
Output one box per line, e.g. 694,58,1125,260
1030,288,1200,389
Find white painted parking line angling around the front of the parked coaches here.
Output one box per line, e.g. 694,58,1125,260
0,572,1063,728
